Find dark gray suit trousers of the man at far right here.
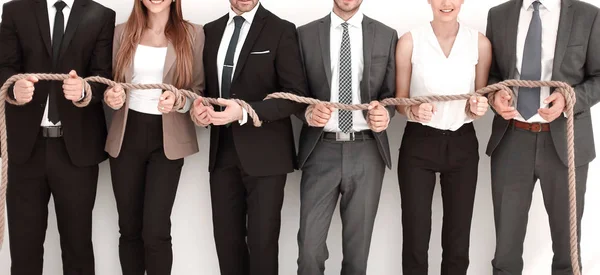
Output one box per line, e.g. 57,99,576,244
491,127,588,275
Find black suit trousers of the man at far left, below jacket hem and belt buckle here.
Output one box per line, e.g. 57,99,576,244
7,132,98,275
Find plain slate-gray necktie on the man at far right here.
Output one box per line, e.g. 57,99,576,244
517,1,542,120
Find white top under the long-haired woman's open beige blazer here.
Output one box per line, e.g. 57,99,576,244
128,44,167,115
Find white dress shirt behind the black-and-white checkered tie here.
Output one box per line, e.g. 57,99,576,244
323,11,369,132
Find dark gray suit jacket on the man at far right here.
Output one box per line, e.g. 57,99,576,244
486,0,600,166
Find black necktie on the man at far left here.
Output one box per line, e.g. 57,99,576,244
48,1,67,124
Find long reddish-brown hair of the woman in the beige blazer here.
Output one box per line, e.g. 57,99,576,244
114,0,194,88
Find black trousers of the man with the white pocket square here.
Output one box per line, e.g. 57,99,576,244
210,127,287,275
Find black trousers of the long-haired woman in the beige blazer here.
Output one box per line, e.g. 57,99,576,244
110,110,183,275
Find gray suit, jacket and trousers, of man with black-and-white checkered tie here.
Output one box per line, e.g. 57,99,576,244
298,15,398,275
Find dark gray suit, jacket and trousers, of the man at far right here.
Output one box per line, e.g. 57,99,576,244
487,0,600,275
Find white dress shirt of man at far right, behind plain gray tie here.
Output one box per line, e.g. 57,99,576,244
515,0,560,123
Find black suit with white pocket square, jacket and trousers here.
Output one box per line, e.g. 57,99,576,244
204,4,306,275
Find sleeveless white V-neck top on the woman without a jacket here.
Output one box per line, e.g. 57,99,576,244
410,23,479,131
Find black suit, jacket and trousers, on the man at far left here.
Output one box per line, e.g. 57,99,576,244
0,0,115,275
